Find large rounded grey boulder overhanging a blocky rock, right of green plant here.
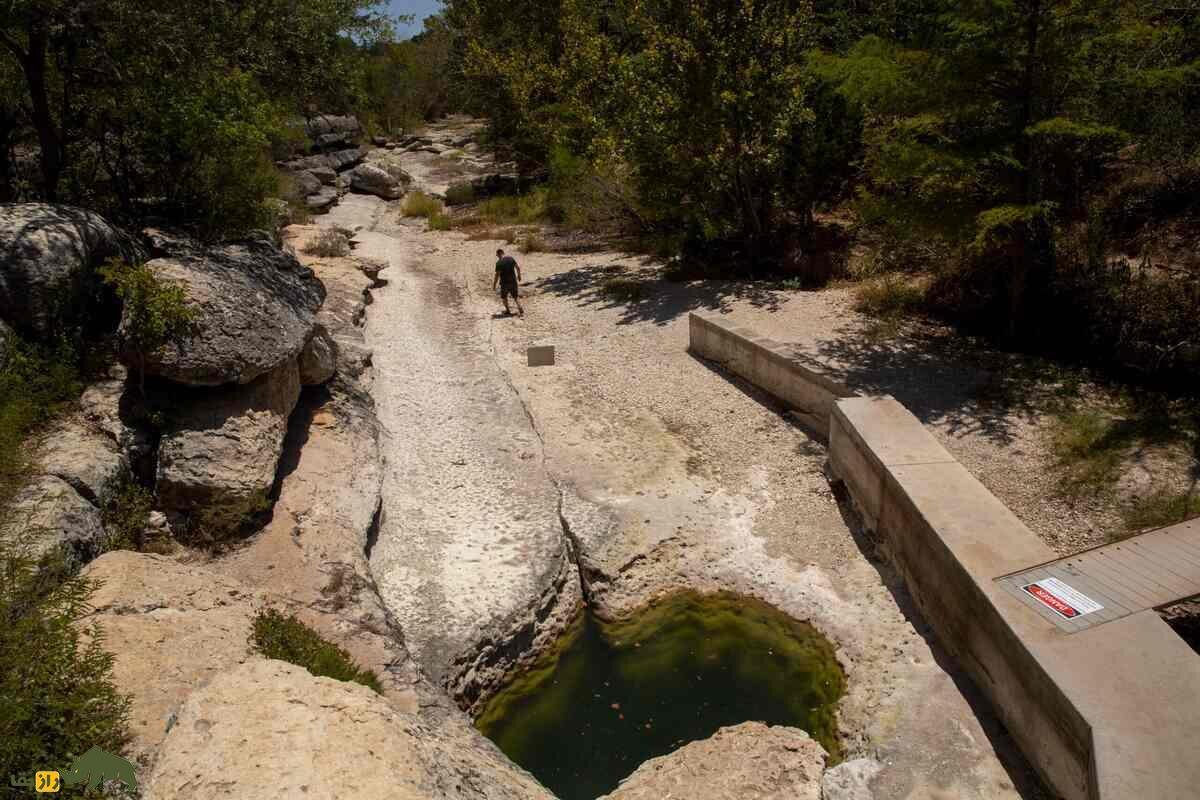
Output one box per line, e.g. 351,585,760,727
121,240,325,386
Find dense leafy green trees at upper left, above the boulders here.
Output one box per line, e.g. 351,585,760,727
0,0,386,230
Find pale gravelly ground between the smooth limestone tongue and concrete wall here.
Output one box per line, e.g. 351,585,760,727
379,221,1042,800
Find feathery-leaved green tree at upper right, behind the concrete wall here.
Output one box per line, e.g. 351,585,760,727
818,0,1161,338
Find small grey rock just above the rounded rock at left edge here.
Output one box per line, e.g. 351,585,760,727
38,417,130,505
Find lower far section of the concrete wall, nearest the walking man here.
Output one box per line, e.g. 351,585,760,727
689,313,854,440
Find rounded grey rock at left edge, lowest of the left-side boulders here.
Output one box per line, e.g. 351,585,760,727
0,475,104,565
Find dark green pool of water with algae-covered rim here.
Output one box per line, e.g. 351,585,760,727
476,593,845,800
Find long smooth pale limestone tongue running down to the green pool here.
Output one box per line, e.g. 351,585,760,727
329,196,580,709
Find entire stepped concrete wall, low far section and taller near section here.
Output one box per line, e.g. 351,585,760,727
691,314,1200,800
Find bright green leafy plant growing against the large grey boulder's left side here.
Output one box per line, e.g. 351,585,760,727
100,259,199,396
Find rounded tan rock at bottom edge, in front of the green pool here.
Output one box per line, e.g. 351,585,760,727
597,722,826,800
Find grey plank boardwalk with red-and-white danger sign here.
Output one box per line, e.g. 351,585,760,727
996,519,1200,633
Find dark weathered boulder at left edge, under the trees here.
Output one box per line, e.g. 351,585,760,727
0,203,144,338
